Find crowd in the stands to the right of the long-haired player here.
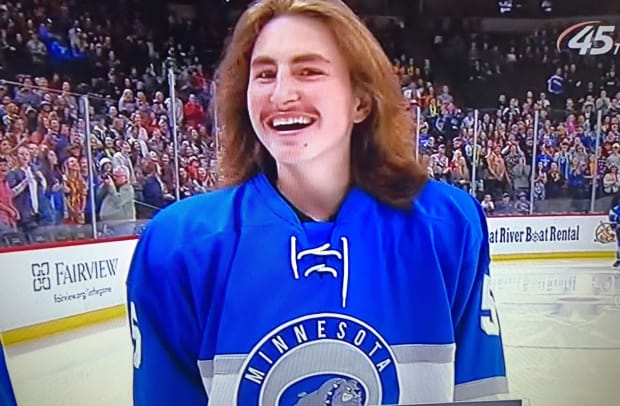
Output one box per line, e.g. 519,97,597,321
394,17,620,215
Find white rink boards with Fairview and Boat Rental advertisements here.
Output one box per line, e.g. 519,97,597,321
0,215,616,344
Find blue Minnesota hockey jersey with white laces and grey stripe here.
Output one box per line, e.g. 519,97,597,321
127,175,507,406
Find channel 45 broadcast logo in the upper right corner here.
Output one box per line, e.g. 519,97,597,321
556,21,620,55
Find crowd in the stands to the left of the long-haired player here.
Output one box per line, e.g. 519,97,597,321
0,0,216,244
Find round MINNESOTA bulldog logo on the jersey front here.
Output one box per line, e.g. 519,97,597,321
235,314,400,406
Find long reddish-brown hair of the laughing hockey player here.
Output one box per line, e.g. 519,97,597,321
214,0,427,209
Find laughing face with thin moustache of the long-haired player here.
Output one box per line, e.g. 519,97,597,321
247,16,364,169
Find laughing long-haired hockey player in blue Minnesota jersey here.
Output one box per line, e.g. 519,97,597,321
127,0,508,406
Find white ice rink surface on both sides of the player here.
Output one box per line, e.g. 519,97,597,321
6,260,620,406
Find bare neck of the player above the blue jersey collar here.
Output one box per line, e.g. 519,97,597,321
277,152,351,221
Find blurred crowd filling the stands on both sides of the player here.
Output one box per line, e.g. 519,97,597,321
0,0,620,246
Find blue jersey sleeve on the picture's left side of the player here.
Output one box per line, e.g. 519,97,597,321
127,217,208,406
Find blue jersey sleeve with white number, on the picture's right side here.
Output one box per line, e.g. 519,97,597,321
454,195,508,401
